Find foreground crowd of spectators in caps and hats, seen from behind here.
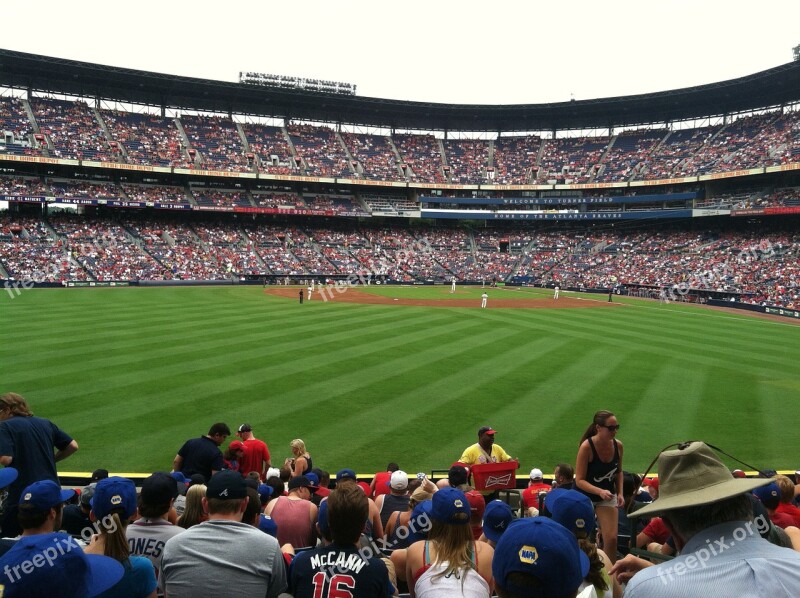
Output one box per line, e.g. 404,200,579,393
0,392,800,598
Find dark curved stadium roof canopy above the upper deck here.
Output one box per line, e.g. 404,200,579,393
0,49,800,132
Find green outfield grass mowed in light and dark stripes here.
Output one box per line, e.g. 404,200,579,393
0,286,800,473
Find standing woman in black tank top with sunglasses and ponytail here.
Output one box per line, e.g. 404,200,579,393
575,411,623,563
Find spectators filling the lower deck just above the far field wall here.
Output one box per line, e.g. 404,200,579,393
0,214,800,308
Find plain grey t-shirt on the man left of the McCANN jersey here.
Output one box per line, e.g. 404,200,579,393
161,519,287,598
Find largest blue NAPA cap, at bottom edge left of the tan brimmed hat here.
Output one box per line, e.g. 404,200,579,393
492,517,589,598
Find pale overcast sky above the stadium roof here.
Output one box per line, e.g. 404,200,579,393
0,0,800,104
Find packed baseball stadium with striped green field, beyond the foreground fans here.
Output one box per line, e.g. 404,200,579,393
0,50,800,492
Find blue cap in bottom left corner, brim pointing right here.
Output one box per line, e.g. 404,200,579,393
0,532,125,598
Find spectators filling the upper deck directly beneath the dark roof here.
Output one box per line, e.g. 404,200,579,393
0,97,800,184
